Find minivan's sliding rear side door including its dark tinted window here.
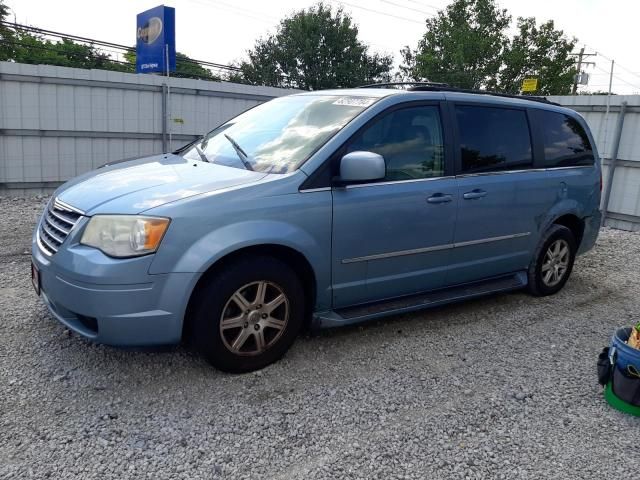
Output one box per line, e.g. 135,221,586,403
447,102,535,285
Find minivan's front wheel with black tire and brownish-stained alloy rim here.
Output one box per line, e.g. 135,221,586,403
192,256,305,373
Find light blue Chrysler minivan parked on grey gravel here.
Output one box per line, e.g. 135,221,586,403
32,84,601,372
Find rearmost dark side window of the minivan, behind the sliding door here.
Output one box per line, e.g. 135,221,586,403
540,111,593,168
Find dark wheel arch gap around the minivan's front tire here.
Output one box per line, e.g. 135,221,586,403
182,243,318,341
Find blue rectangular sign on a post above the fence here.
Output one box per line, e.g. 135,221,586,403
136,5,176,73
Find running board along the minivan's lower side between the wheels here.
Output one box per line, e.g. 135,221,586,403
314,272,527,328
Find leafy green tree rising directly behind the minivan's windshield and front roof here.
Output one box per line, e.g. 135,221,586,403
239,3,393,90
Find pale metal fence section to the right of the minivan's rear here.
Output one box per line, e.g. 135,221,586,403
549,95,640,231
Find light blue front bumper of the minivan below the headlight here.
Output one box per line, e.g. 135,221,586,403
31,232,197,346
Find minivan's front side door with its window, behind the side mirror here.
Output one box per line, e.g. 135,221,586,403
332,103,458,308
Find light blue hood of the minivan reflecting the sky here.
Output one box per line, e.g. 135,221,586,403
56,154,267,215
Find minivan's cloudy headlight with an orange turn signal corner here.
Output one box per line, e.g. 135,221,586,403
80,215,169,257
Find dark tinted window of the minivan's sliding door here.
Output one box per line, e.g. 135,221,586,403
456,105,533,173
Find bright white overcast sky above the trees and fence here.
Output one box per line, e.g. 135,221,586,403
5,0,640,94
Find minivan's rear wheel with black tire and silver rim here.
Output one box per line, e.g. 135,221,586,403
528,225,577,297
